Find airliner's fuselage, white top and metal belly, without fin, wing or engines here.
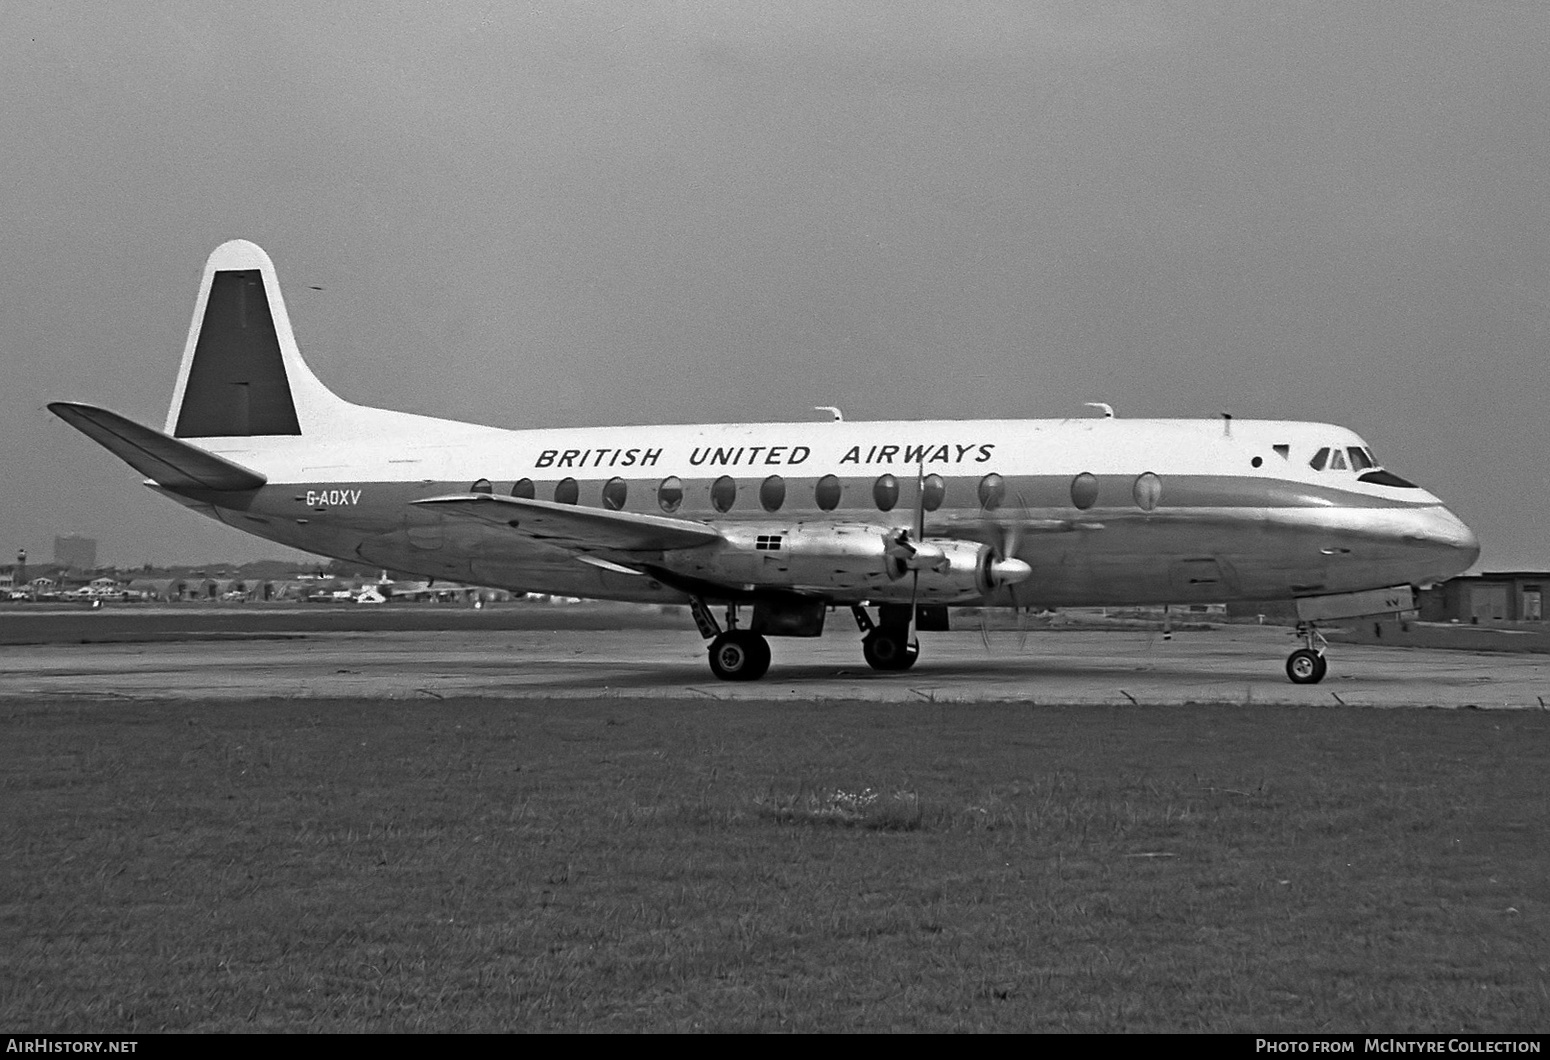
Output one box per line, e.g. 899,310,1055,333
172,417,1477,606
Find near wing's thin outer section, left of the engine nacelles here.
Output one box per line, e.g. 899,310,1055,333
414,493,721,552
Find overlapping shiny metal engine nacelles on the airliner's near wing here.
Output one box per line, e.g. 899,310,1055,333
663,524,1032,603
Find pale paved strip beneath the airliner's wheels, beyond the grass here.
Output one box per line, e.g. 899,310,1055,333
0,626,1550,710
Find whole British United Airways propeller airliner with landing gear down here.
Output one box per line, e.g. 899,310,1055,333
50,240,1479,683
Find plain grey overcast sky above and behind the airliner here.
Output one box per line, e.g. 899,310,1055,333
0,0,1550,569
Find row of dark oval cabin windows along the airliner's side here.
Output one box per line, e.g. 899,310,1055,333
483,471,1163,515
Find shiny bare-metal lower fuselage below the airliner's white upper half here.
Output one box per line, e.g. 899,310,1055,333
158,479,1479,607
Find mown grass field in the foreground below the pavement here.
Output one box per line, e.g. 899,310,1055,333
0,700,1550,1032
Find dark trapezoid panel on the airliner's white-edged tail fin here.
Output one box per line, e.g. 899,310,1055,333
172,268,301,439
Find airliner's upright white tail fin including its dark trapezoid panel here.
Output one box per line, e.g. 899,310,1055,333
166,239,349,439
